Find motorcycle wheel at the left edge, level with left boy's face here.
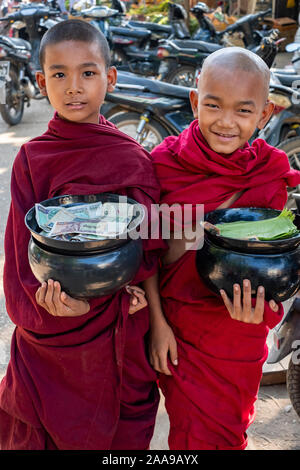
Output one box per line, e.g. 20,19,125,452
0,69,24,126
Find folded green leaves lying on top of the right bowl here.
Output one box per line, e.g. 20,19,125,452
215,209,299,240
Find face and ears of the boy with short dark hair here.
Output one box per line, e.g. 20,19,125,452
36,41,117,124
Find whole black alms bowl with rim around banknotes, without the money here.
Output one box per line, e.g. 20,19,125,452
25,194,144,298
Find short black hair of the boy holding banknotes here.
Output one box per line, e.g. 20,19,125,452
39,19,111,70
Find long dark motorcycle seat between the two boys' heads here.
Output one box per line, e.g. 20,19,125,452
117,72,191,99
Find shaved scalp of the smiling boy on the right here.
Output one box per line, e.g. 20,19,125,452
198,47,270,100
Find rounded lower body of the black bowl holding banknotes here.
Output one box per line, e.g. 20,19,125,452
28,237,143,299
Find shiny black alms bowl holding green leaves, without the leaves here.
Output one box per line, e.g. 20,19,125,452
196,208,300,302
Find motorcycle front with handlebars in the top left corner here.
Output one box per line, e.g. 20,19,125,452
0,3,63,69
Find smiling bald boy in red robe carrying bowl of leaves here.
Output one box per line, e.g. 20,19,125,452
144,47,300,450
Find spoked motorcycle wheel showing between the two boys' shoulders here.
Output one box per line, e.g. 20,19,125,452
109,112,170,152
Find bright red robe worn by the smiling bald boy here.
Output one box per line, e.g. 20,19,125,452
152,121,300,450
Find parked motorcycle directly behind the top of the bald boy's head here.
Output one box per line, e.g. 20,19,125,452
157,10,275,87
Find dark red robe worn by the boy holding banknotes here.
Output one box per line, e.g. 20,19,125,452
0,115,162,450
